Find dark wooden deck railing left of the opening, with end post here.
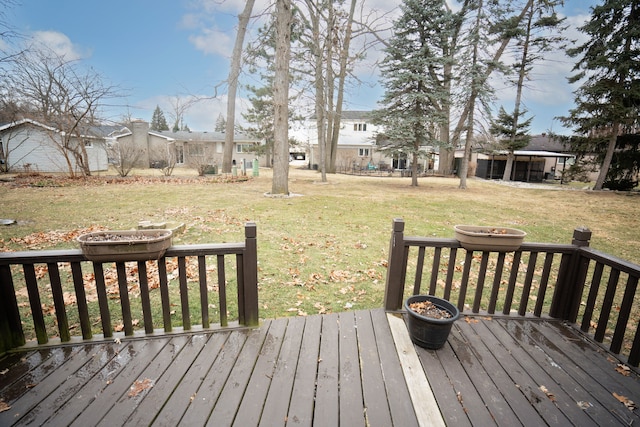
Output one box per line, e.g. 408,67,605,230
0,223,258,354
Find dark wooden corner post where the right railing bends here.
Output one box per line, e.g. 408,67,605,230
549,227,592,322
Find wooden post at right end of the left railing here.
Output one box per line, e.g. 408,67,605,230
239,222,259,326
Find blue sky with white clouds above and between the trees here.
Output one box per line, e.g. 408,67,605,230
7,0,598,133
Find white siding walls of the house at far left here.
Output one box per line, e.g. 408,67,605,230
1,124,108,173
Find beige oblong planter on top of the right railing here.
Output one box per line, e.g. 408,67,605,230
453,225,527,252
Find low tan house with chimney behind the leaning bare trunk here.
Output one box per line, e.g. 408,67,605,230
115,120,270,169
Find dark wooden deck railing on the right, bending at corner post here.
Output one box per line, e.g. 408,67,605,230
384,219,640,367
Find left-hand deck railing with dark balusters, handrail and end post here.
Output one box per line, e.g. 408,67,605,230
0,222,259,354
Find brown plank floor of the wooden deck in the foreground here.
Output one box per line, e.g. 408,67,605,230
0,309,640,426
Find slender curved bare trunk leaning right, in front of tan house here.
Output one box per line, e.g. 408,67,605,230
222,0,255,173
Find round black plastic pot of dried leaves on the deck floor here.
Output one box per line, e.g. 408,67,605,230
404,295,460,350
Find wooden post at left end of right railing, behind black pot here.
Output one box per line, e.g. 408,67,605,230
384,218,407,311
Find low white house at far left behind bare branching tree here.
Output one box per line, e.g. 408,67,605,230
0,119,108,173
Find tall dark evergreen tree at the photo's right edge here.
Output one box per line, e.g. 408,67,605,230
560,0,640,190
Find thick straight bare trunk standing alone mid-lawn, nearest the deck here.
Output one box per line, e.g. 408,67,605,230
271,0,293,195
